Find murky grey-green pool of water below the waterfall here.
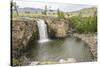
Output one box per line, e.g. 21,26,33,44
27,36,92,62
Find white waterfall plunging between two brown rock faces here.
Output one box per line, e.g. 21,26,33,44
37,19,49,43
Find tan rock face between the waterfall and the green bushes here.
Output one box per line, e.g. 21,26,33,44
47,19,68,38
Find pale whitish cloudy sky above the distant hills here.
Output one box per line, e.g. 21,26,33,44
13,0,94,12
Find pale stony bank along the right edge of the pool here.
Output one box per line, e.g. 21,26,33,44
73,33,97,61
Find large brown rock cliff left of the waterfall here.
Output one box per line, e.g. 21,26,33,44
12,18,37,49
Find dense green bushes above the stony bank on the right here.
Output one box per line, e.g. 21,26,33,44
70,16,97,33
